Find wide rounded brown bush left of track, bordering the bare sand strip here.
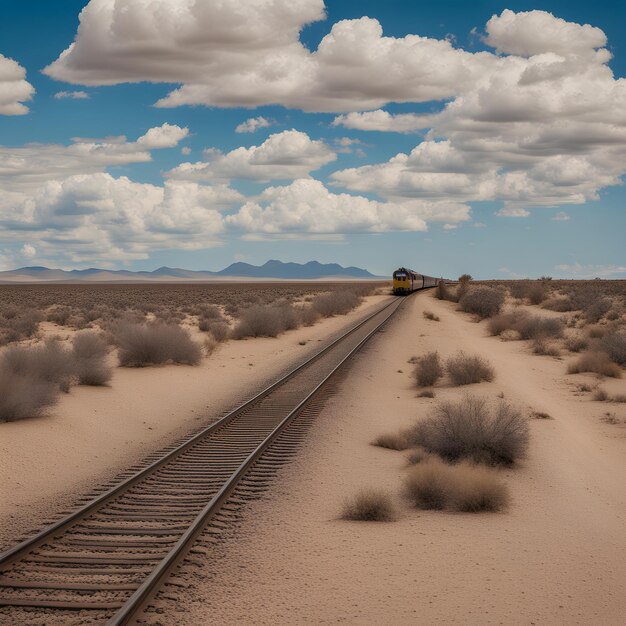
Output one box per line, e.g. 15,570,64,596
112,322,202,367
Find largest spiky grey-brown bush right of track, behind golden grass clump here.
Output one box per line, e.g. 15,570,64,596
408,396,528,465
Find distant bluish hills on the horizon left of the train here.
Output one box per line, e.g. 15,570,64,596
0,260,377,283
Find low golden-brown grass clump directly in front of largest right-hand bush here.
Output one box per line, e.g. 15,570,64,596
405,458,508,513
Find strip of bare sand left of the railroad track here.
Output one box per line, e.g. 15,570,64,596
0,296,386,546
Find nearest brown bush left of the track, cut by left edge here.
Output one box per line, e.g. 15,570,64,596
0,360,59,422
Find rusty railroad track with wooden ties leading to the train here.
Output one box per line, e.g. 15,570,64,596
0,298,403,626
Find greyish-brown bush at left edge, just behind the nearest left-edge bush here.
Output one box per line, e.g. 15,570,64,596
2,339,75,392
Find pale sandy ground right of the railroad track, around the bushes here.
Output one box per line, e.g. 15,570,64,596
171,293,626,626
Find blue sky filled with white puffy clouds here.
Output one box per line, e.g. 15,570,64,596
0,0,626,278
